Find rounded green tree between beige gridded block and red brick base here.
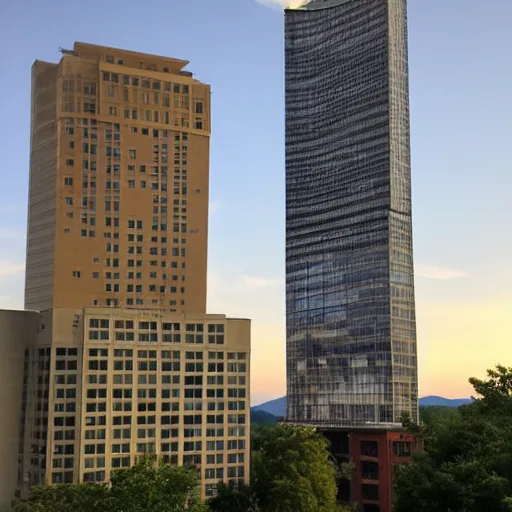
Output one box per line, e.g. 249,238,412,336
210,425,339,512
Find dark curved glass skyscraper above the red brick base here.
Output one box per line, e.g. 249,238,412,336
285,0,418,426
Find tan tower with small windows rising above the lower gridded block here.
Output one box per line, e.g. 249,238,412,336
25,43,210,313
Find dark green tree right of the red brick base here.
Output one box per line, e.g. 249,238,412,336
396,366,512,512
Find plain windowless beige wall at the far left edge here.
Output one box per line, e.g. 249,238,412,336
0,310,39,511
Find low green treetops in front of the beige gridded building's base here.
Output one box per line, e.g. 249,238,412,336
13,458,204,512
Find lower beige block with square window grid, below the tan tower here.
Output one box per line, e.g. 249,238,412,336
18,308,250,497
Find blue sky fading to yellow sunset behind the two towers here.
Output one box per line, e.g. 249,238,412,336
0,0,512,404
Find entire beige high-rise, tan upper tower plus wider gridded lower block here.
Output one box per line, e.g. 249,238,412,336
0,43,250,508
